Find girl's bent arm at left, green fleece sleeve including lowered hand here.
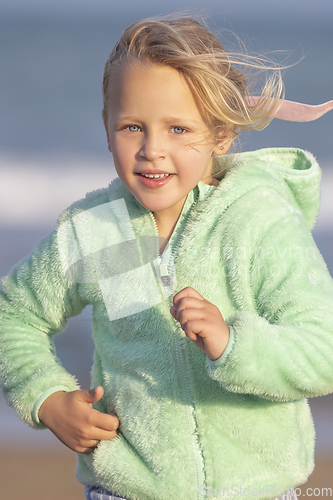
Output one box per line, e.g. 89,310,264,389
0,225,119,453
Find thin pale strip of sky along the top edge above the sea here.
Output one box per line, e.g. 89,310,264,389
0,0,333,23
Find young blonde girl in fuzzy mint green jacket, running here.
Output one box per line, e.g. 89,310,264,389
0,15,333,500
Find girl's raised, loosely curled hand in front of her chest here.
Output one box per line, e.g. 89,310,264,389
170,287,229,360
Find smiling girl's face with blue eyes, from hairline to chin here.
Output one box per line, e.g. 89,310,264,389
105,62,227,224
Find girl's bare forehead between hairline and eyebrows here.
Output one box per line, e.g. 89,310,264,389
108,62,202,119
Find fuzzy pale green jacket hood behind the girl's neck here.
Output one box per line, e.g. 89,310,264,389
214,148,321,228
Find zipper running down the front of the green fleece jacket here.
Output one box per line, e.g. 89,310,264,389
150,212,206,499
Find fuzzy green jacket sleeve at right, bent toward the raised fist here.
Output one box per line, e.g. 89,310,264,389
207,189,333,401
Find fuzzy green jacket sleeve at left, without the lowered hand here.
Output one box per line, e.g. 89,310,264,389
0,223,86,428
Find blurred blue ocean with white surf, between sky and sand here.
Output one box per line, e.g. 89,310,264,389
0,7,333,452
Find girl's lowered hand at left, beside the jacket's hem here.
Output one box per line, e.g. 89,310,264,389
38,386,119,453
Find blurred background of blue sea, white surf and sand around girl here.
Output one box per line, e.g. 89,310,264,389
0,0,333,500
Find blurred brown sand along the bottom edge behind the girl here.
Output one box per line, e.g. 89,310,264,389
0,448,333,500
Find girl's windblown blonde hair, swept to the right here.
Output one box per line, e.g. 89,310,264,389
102,18,284,160
